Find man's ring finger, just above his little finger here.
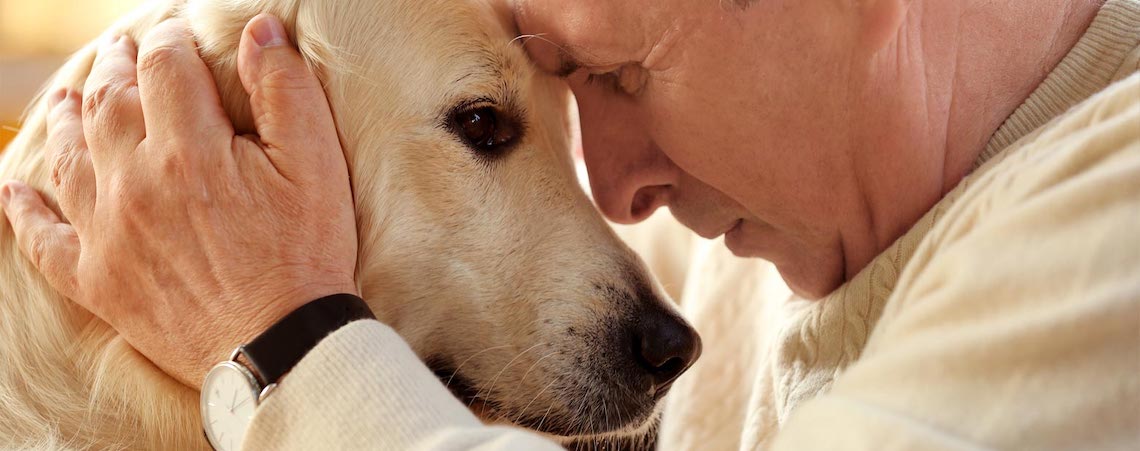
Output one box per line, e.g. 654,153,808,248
44,89,96,230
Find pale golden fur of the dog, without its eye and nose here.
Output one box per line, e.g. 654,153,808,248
0,0,688,449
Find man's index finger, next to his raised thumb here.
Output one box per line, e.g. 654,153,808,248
138,19,234,151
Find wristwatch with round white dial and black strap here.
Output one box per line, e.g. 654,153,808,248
201,294,376,451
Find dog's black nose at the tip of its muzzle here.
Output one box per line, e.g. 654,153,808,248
633,309,701,397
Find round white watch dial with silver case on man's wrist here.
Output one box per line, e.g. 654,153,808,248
202,362,258,451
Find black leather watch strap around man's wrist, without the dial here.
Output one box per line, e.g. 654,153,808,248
238,294,376,386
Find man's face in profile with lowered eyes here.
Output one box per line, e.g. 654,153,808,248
515,0,860,296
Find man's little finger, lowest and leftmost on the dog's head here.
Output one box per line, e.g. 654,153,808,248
0,182,81,300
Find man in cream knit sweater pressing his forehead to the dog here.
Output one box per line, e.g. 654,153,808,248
0,0,1140,450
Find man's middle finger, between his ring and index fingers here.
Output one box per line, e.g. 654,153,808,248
82,36,146,161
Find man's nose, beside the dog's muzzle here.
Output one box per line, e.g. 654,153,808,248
579,96,679,224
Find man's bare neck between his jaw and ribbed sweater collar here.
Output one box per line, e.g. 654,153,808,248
842,0,1104,282
